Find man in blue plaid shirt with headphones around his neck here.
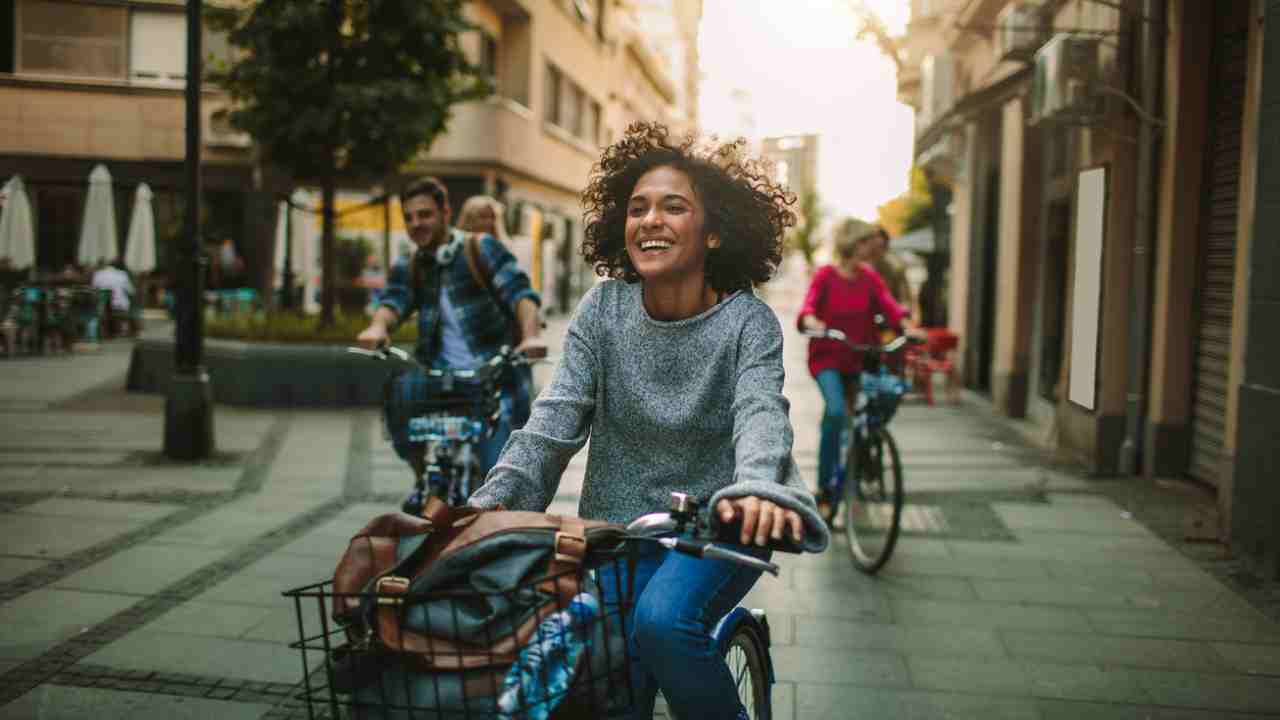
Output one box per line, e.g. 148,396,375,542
357,177,547,497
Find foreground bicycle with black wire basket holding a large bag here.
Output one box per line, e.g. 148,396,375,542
283,493,800,720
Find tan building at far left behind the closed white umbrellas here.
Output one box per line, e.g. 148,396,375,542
0,0,252,278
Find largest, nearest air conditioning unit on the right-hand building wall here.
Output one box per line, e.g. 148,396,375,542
1030,33,1103,124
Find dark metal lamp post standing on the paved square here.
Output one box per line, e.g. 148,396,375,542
164,0,214,460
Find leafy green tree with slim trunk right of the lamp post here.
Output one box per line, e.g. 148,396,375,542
209,0,492,325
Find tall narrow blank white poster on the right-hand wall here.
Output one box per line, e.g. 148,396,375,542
1068,168,1107,410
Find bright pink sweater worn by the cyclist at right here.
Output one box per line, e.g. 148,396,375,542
796,263,906,377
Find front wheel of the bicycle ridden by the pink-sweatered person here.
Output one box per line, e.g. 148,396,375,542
845,428,904,574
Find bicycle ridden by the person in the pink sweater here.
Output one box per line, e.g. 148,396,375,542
804,328,922,574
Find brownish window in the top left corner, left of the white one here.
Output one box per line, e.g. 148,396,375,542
18,0,128,79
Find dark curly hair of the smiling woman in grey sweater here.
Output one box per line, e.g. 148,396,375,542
582,122,796,292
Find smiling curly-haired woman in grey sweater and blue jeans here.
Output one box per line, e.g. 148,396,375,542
471,123,829,720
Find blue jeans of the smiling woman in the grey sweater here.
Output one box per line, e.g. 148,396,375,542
600,543,771,720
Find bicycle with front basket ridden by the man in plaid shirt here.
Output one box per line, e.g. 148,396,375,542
347,345,549,516
